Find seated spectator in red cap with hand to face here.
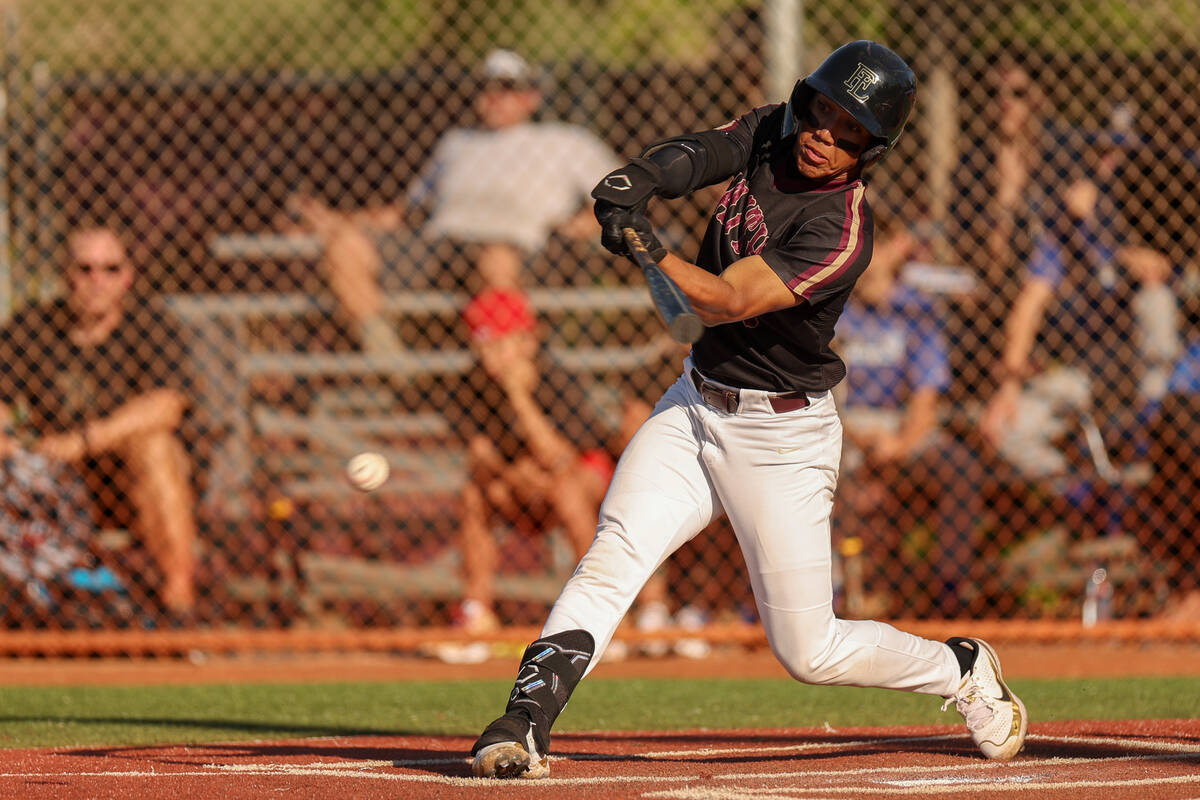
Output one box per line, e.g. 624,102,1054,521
438,289,707,660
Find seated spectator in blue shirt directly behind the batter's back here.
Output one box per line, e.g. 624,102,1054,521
836,216,979,616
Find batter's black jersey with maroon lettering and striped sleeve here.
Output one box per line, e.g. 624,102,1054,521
692,104,875,392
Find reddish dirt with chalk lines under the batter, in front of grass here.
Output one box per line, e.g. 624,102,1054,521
0,720,1200,800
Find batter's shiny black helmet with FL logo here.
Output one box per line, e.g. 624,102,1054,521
784,40,917,164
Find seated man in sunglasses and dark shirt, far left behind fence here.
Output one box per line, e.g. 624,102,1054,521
0,228,197,618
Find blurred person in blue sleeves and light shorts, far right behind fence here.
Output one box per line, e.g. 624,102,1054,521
980,120,1178,513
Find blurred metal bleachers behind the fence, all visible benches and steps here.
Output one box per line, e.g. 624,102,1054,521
163,235,674,618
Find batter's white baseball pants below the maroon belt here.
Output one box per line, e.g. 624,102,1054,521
542,359,960,697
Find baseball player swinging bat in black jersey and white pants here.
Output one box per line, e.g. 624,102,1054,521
472,41,1027,778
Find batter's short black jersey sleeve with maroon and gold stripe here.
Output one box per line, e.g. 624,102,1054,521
760,184,874,302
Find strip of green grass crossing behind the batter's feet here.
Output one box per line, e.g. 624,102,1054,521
0,678,1200,747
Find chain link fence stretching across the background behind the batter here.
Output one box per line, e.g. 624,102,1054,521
0,0,1200,652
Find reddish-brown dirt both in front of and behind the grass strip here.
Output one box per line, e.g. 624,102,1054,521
0,643,1200,800
